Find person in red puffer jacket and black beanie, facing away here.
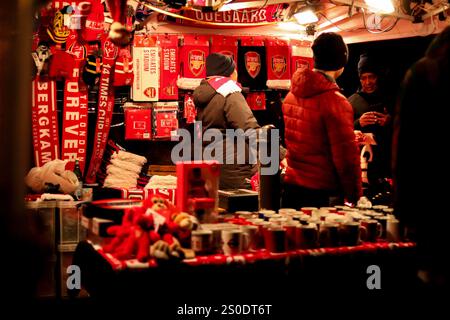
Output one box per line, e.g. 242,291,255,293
282,33,362,208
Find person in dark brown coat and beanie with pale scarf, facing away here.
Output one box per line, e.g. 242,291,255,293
194,53,260,189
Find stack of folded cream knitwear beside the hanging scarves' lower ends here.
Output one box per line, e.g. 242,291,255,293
103,150,147,188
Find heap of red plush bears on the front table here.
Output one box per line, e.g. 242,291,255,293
103,197,195,262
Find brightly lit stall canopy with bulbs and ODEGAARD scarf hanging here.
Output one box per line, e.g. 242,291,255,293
134,0,450,43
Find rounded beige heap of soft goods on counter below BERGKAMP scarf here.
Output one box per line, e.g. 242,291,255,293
25,159,79,193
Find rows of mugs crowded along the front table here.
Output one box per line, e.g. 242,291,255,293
191,206,401,255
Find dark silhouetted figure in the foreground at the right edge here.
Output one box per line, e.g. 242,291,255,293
392,27,450,293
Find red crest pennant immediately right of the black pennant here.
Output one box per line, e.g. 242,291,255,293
266,39,291,90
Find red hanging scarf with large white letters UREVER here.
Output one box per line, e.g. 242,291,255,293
61,42,88,173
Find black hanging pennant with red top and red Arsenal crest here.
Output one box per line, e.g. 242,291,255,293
238,37,267,90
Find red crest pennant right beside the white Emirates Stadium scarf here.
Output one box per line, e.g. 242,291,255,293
177,35,209,90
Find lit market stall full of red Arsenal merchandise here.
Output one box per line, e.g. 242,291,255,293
22,0,449,298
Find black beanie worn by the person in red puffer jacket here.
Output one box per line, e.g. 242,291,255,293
312,32,348,71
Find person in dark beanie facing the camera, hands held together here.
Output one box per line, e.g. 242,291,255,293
348,54,393,193
